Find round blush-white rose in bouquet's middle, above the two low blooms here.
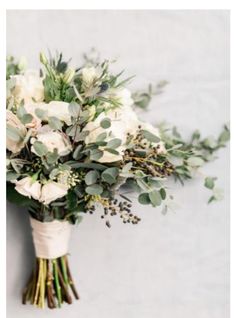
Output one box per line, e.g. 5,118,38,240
31,125,72,156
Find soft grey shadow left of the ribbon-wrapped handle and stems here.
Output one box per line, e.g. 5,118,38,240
7,203,34,302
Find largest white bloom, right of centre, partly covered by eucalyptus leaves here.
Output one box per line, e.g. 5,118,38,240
84,106,139,162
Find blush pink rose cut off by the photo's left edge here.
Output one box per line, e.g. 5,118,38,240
6,110,27,153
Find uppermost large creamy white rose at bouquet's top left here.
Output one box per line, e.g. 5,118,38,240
9,71,44,104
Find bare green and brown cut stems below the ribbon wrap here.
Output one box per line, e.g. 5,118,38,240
22,255,79,309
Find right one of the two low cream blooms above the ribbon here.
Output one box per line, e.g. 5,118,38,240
40,181,68,204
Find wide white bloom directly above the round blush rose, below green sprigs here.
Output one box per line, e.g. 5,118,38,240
25,101,71,126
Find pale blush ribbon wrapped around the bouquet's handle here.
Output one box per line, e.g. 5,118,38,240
30,218,72,259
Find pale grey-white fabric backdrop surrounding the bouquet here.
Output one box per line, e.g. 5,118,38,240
7,11,229,318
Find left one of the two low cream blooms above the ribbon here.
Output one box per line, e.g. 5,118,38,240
15,177,41,200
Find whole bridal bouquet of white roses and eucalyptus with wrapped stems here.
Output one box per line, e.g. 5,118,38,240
6,54,229,308
